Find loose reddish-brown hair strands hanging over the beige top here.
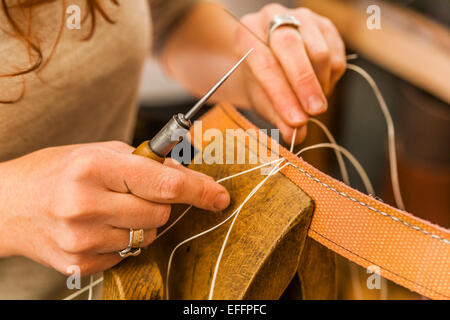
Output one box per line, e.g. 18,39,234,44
0,0,119,104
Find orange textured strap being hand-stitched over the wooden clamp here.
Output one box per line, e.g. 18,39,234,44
194,103,450,299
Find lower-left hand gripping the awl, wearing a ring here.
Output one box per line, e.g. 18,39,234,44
0,142,230,276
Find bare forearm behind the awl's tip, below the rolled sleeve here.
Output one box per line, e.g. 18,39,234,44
161,2,250,107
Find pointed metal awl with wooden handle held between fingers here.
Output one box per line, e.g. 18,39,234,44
133,48,253,163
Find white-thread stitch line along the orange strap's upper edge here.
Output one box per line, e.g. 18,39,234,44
221,107,450,244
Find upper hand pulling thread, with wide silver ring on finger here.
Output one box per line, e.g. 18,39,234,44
236,3,346,143
